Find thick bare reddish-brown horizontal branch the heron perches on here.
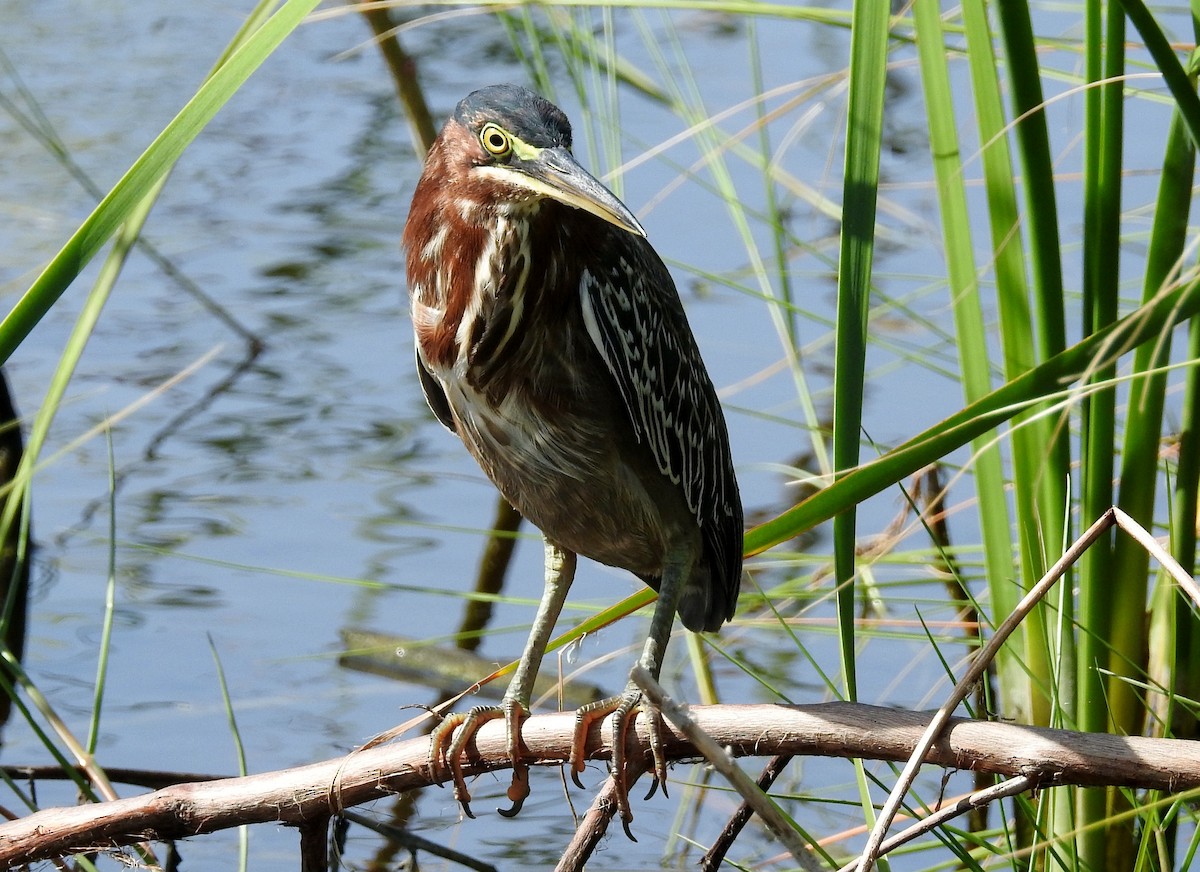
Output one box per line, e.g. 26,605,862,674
0,703,1200,866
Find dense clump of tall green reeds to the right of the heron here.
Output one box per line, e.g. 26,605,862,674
511,0,1200,870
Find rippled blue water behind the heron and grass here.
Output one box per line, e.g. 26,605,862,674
0,0,1180,870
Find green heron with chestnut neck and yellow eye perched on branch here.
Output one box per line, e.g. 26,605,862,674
403,85,743,831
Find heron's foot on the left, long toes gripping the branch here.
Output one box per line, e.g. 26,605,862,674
428,697,529,818
